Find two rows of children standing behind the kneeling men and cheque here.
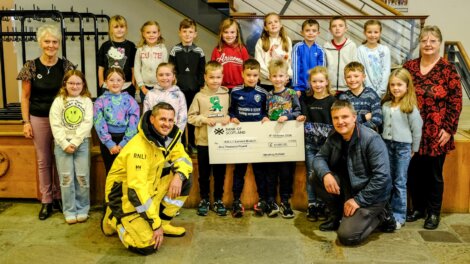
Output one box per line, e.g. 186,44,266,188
51,13,422,229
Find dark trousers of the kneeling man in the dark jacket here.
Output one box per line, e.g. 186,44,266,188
312,173,385,245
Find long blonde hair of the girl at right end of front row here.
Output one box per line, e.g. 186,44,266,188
382,68,418,114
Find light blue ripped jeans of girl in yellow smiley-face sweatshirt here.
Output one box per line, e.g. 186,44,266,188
54,138,90,219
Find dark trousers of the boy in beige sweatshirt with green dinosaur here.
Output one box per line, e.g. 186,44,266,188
197,146,226,201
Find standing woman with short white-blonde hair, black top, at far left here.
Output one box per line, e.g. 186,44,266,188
16,24,75,220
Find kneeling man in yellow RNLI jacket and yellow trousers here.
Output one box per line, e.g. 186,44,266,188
101,102,192,255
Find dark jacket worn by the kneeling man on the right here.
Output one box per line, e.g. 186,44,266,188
313,123,392,207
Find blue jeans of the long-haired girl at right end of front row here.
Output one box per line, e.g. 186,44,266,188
384,139,411,225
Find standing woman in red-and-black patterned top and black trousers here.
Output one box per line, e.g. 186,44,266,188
403,26,462,229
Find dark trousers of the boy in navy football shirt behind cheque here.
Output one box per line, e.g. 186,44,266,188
232,163,268,200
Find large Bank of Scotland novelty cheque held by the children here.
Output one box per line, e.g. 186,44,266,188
207,121,305,164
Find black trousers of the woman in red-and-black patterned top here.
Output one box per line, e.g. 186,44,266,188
408,153,446,215
